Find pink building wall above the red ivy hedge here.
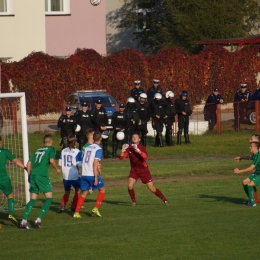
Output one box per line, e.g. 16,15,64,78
46,0,106,56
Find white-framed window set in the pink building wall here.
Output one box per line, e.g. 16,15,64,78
45,0,70,15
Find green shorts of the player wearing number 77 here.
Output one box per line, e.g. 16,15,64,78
30,175,52,194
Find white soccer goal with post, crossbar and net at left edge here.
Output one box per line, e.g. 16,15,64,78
0,93,29,210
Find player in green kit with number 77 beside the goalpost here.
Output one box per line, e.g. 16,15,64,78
20,134,61,229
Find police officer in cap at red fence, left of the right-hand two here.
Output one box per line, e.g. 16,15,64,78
204,88,224,130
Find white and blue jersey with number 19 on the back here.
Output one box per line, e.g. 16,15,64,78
59,148,82,180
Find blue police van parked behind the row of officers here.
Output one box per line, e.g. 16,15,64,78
65,89,118,129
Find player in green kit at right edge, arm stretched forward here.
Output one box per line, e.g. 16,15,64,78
234,142,260,207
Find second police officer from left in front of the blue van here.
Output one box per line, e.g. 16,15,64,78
74,102,93,150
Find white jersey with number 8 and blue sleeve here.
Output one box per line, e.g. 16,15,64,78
82,143,103,176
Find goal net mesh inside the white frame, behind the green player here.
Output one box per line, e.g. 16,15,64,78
0,98,26,210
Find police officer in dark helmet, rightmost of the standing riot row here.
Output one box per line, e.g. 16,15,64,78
175,90,192,144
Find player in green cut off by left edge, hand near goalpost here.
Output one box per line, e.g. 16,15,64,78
0,136,27,225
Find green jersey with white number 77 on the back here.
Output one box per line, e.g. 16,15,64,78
29,146,56,177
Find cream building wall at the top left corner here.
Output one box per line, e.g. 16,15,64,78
0,0,46,61
